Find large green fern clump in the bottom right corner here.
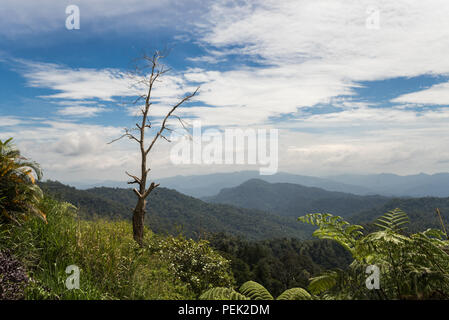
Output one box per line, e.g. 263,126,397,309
299,209,449,299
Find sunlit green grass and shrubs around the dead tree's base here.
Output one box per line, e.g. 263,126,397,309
0,198,233,299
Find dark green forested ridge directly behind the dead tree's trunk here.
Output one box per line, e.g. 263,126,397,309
40,181,311,240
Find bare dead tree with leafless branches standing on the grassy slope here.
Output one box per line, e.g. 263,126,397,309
110,51,199,246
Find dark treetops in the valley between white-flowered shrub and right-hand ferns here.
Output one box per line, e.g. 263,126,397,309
209,234,351,296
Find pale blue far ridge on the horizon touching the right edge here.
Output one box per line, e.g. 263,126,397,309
327,173,449,197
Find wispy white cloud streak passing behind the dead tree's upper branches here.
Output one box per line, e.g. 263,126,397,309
15,59,195,105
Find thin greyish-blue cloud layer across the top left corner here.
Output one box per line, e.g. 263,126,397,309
0,0,204,37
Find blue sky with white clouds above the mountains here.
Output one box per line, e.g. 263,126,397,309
0,0,449,182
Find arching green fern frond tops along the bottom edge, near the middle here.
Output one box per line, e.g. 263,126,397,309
200,281,312,300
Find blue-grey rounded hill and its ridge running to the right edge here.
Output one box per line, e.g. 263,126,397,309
205,179,449,232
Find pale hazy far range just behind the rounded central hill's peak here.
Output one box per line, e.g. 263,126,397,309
158,171,372,198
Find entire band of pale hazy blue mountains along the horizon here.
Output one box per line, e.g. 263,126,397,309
68,171,449,198
